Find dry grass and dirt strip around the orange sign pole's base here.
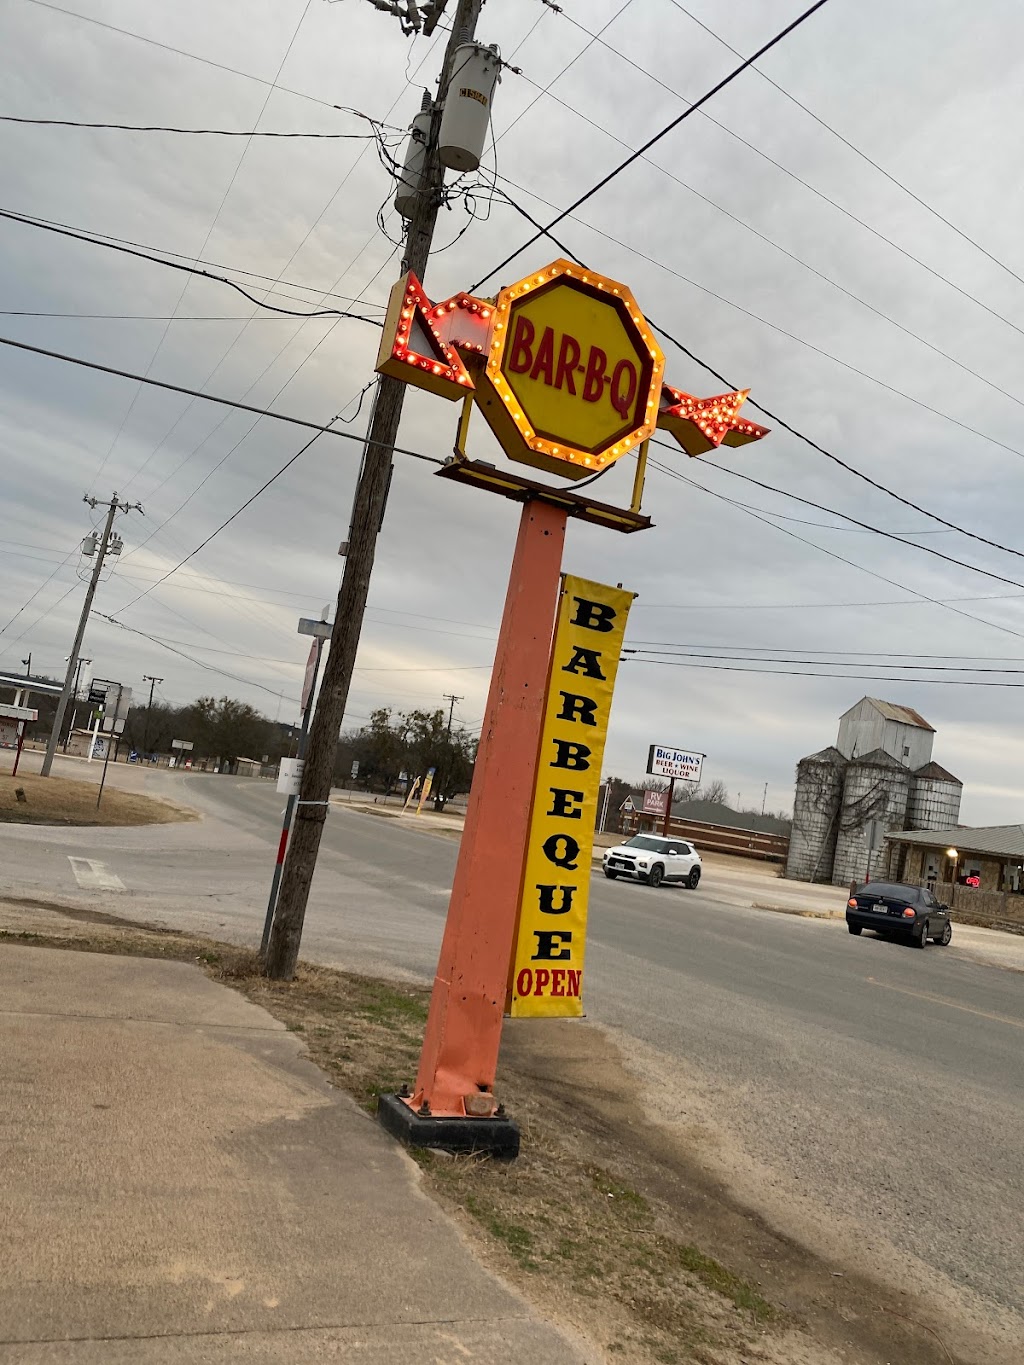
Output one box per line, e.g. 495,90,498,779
0,901,960,1365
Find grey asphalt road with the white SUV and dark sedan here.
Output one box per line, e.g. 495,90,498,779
3,775,1024,1358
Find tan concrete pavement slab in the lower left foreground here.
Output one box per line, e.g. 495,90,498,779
0,945,597,1365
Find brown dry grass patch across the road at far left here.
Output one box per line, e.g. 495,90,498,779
0,773,199,824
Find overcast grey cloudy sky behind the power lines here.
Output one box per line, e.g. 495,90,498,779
0,0,1024,823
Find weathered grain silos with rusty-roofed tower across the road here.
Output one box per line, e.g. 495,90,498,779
786,696,963,886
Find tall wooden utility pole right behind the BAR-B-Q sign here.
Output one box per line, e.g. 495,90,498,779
266,0,483,981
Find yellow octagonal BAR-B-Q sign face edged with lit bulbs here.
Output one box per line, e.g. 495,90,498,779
483,261,665,478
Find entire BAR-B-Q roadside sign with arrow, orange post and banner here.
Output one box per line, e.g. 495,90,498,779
377,261,766,1156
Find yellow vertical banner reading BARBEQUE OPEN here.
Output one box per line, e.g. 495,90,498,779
507,575,634,1018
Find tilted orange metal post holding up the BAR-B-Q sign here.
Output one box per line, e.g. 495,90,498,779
407,500,567,1118
